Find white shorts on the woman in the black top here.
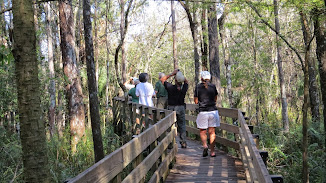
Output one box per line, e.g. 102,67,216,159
196,110,220,129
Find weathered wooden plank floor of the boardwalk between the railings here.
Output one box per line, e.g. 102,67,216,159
165,141,246,183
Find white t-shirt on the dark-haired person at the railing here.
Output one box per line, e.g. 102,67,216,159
136,82,155,107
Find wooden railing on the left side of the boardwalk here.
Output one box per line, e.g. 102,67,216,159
69,98,178,183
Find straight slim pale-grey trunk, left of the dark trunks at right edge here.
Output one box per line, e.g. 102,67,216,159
274,0,289,132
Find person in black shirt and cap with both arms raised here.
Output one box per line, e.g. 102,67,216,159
160,69,188,148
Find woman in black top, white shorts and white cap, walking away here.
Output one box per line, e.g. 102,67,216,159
194,71,220,157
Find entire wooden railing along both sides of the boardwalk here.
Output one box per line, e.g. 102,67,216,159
69,98,283,183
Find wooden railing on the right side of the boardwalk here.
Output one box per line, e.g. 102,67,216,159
182,104,283,183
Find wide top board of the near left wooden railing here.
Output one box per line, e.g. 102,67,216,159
69,112,176,182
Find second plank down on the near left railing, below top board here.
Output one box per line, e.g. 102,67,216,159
122,128,176,183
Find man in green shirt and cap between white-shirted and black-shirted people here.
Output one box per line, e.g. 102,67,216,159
155,72,168,109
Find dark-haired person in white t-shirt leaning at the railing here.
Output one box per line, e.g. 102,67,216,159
136,73,155,107
